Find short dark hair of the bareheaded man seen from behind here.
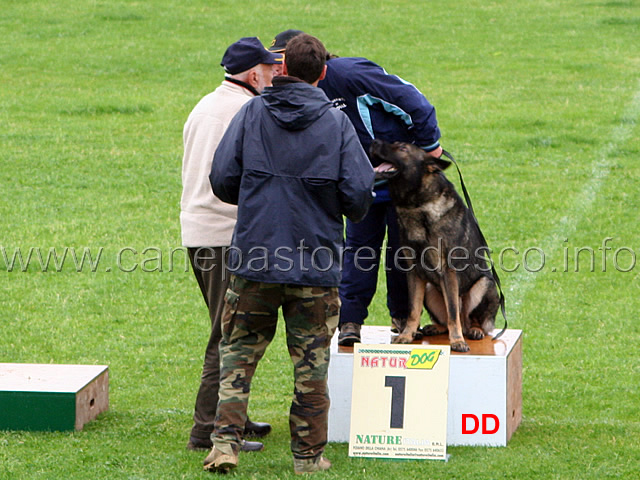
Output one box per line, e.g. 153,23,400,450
284,33,328,83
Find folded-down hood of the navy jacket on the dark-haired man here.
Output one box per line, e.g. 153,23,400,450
260,77,333,130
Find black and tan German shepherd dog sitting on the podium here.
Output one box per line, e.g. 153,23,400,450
370,140,500,352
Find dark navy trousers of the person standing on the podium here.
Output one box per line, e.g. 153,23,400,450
339,202,409,324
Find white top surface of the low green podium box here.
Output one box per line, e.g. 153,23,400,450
0,363,109,393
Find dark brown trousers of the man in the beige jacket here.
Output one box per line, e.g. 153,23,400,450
187,247,229,440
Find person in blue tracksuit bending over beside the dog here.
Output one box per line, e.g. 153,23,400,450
318,55,442,345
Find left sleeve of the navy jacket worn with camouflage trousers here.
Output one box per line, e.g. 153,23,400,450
209,105,246,205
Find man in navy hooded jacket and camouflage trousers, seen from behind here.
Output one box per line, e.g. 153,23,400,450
205,35,374,473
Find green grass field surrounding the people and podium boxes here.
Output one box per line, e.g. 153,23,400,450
0,0,640,480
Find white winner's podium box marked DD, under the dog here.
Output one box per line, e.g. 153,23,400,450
329,325,522,446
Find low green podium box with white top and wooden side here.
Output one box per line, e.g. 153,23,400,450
0,363,109,431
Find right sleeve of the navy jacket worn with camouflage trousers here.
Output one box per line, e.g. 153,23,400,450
338,115,375,222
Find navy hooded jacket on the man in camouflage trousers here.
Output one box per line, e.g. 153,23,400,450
209,77,374,287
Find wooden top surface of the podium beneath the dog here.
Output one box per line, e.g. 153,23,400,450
331,325,522,356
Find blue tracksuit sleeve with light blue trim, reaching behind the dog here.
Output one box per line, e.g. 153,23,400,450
352,61,440,151
